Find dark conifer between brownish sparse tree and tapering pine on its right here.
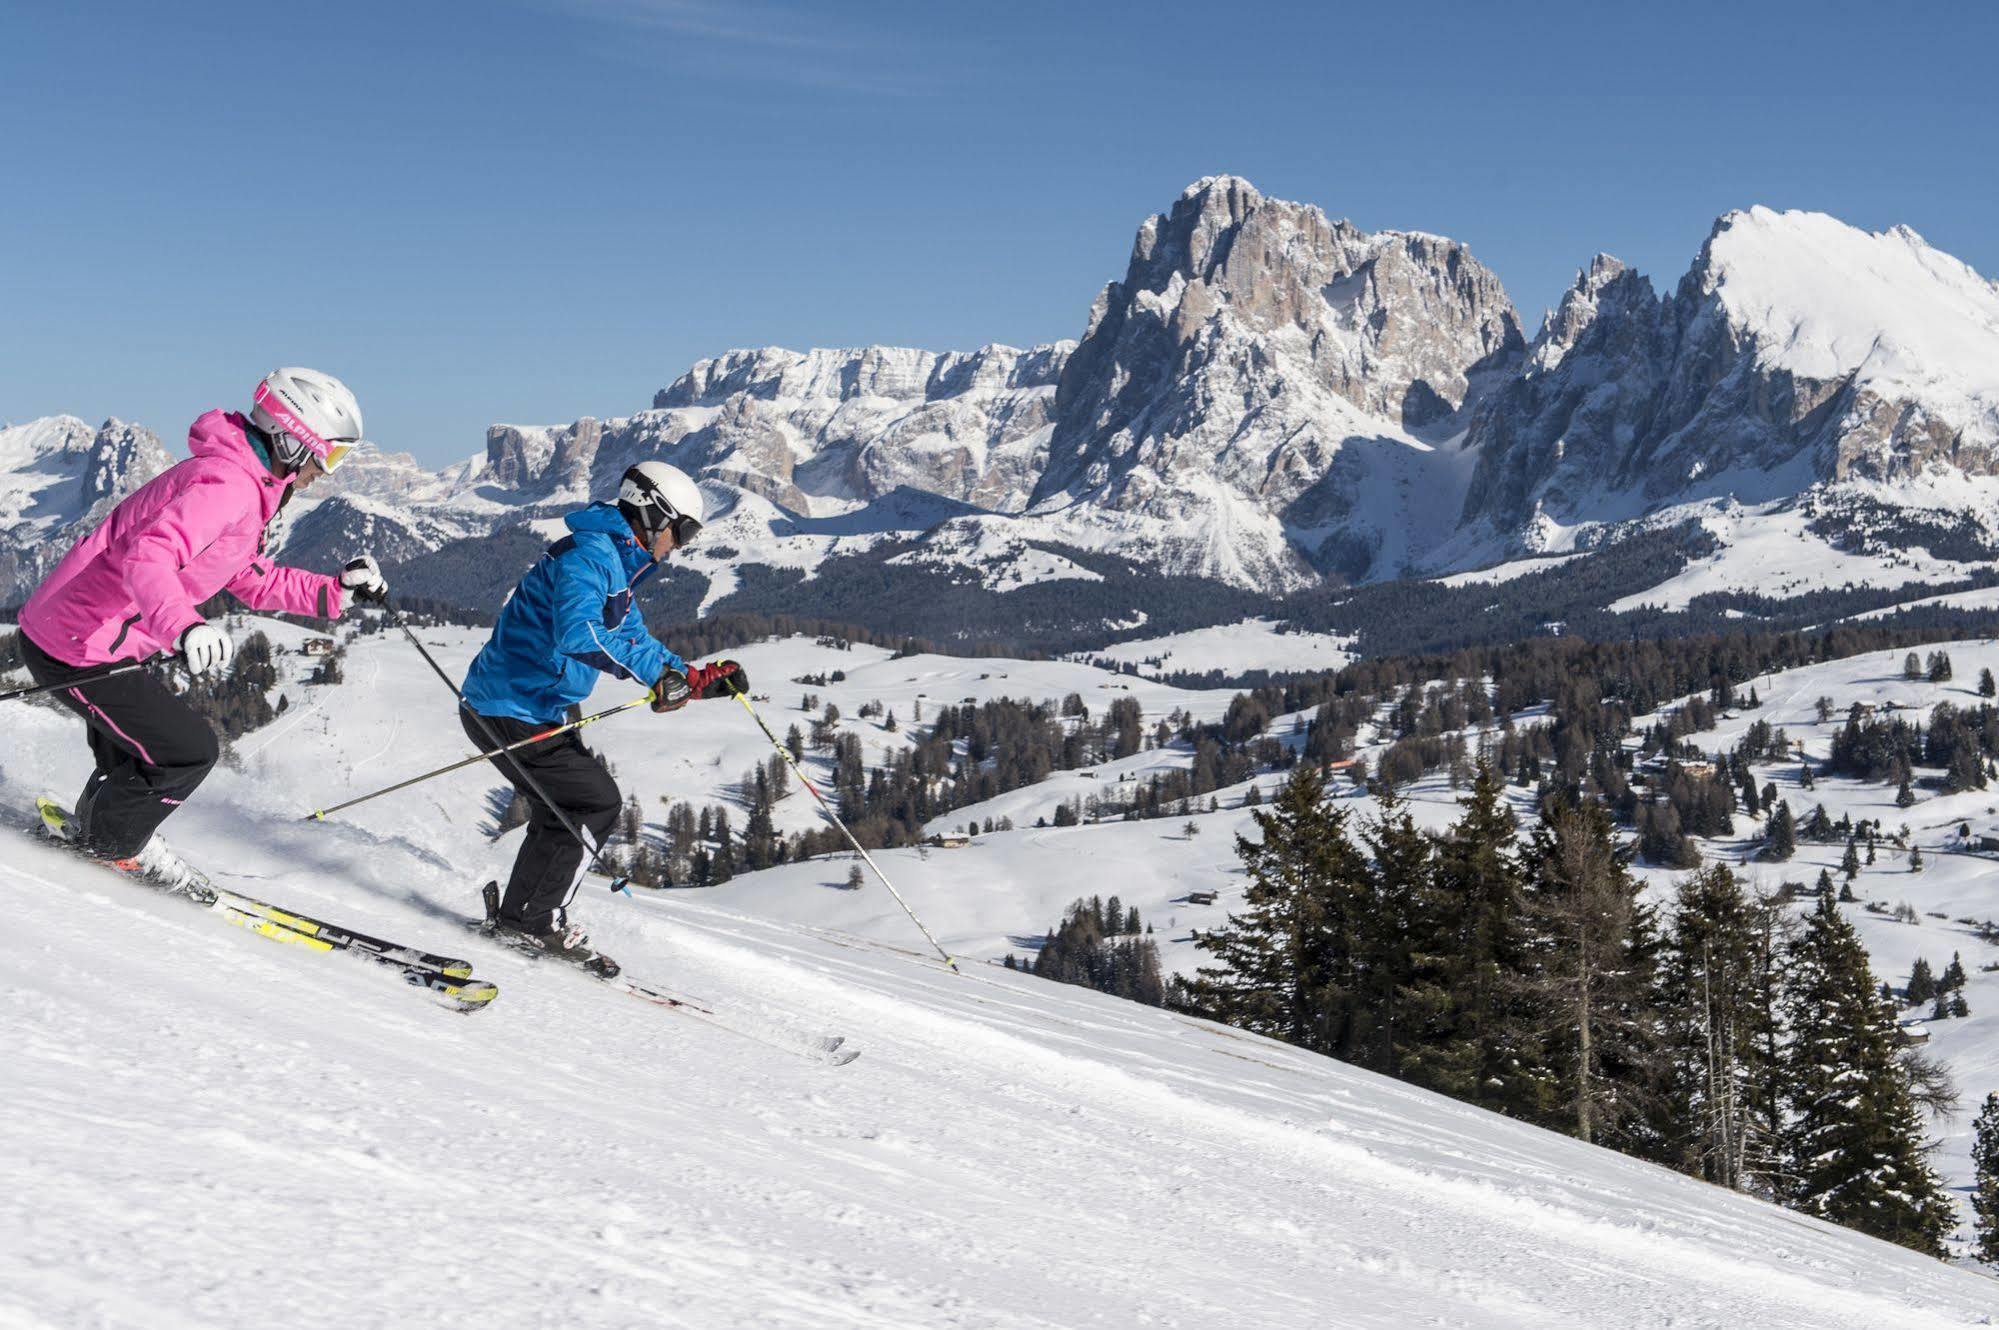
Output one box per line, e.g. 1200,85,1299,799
1661,864,1777,1192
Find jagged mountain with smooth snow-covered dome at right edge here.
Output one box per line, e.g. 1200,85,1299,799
1463,208,1999,550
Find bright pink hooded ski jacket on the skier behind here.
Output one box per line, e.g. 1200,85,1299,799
20,410,342,666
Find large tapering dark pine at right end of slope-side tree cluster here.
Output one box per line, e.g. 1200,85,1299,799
1783,896,1955,1256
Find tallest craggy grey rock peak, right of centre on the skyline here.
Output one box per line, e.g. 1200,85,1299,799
1035,176,1525,586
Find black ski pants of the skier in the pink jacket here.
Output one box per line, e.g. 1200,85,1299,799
16,632,222,858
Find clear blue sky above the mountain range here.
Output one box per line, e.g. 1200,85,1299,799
0,0,1999,464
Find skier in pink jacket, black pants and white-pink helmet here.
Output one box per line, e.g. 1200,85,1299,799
20,368,388,888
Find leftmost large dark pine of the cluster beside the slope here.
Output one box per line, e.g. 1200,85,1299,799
1189,762,1367,1056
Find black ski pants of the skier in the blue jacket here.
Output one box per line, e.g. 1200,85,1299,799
458,706,622,932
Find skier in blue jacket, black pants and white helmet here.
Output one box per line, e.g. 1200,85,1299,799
460,462,750,978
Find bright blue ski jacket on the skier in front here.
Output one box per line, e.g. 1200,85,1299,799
464,504,688,724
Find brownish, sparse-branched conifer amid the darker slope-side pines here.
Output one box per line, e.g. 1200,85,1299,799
1525,802,1659,1152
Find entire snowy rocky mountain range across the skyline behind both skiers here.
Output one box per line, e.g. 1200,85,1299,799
0,176,1999,664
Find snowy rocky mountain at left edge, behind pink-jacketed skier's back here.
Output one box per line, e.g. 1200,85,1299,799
0,416,172,606
